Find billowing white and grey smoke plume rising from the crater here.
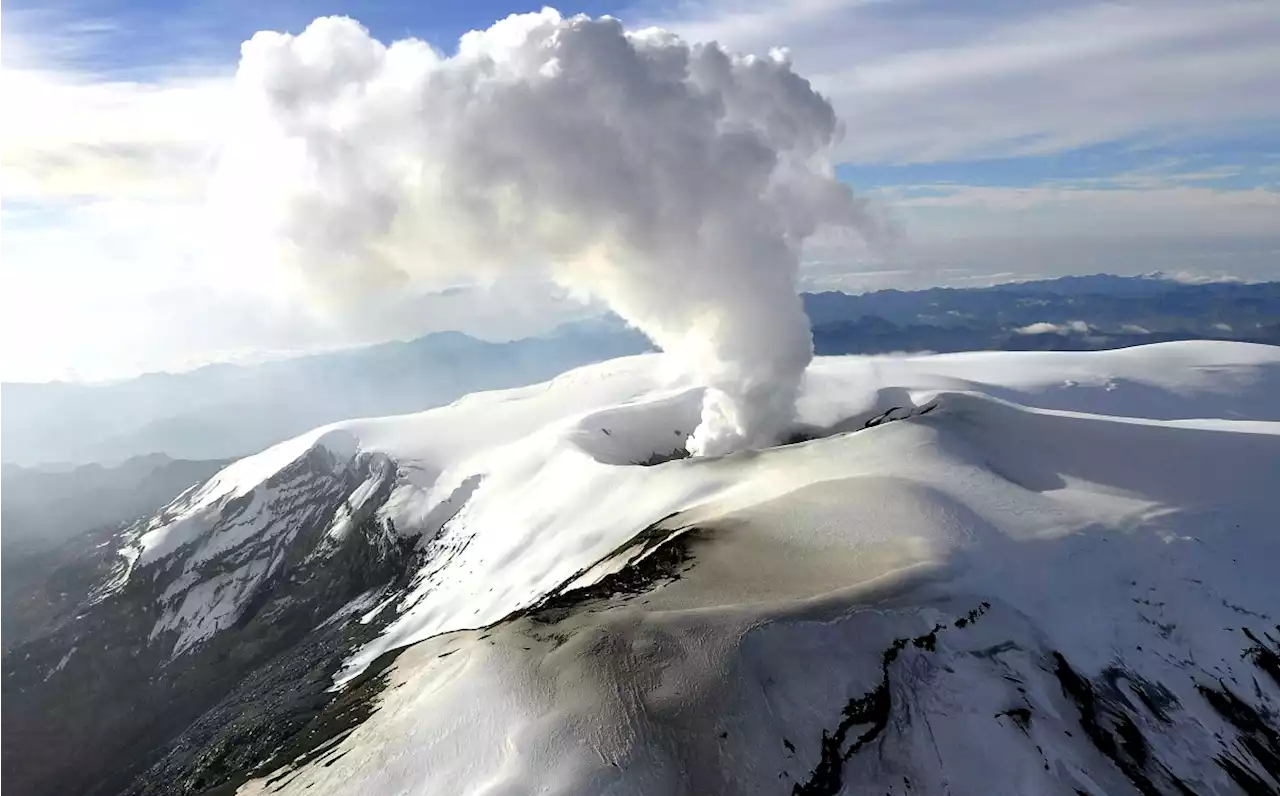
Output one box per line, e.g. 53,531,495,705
227,9,868,454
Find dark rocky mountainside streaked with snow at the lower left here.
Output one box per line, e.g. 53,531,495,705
0,447,413,796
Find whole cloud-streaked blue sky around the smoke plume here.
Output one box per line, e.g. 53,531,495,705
0,0,1280,380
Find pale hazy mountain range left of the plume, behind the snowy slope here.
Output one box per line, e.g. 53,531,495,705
0,321,649,467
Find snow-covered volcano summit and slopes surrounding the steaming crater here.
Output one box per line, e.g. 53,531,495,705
105,343,1280,795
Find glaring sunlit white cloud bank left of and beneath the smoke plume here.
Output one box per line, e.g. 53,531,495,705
0,9,604,381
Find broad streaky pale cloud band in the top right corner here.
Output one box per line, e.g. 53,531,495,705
640,0,1280,163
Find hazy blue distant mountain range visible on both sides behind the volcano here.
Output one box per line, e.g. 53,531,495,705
0,274,1280,466
